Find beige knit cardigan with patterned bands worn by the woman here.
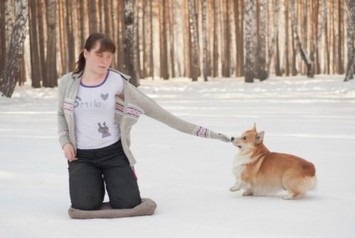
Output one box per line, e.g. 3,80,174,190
57,69,230,166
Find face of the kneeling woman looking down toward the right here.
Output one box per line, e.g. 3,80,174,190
84,43,113,74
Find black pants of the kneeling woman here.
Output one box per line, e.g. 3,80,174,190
68,141,142,210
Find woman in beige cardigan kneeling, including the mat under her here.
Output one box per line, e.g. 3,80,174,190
58,33,230,218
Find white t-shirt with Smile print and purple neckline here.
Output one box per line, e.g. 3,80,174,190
74,71,123,149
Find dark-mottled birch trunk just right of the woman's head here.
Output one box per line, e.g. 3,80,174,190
123,0,139,86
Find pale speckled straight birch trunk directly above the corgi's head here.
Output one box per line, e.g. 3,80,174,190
244,0,256,83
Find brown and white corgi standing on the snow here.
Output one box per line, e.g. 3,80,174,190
230,125,317,199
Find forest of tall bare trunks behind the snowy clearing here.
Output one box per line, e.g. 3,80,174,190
0,0,355,97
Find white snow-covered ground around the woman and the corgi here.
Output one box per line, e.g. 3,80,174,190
0,76,355,238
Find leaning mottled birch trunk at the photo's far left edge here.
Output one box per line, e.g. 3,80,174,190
0,0,28,97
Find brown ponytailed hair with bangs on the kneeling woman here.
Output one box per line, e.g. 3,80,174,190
74,33,116,76
